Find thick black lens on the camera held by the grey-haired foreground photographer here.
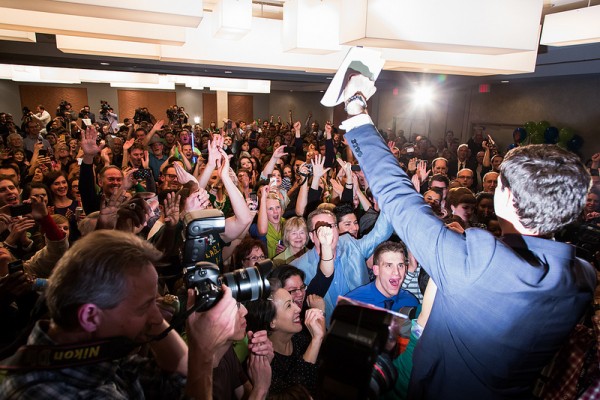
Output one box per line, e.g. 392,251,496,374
221,267,271,302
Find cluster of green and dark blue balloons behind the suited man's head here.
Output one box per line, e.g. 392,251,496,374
513,121,583,153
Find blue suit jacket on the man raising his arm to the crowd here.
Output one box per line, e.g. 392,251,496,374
346,120,596,399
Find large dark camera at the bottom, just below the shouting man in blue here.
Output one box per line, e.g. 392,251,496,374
319,298,406,400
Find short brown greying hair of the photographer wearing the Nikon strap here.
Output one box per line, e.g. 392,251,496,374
46,230,162,330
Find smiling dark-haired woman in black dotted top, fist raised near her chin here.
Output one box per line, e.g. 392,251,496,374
246,288,325,397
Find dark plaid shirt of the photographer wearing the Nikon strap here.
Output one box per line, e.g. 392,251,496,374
0,321,186,400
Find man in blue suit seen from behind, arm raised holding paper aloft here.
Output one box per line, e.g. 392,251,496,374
326,57,596,399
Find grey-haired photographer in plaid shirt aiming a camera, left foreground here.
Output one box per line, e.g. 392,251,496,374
0,231,244,399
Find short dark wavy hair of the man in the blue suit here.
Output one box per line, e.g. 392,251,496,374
500,145,591,235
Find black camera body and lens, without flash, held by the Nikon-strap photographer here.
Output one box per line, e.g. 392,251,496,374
184,260,273,312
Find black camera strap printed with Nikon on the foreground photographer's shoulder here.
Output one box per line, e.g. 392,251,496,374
0,337,140,372
